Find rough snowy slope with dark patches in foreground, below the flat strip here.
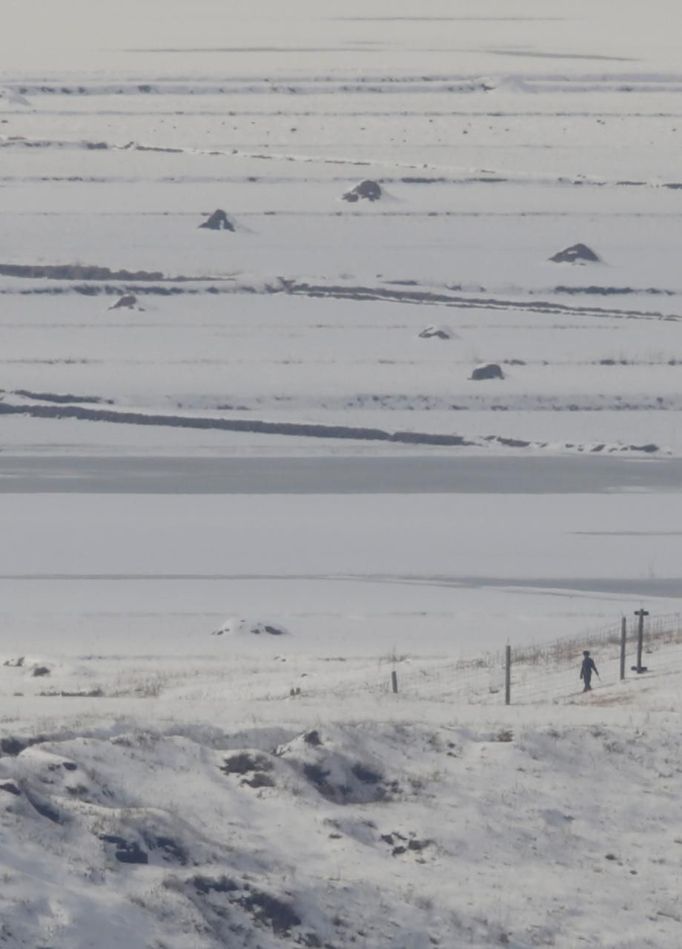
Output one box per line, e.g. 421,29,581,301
0,720,681,949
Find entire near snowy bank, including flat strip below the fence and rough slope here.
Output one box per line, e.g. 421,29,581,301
0,641,682,949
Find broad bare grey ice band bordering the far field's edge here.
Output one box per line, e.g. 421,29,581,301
0,455,682,494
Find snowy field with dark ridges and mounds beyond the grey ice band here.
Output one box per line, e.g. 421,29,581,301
0,0,682,454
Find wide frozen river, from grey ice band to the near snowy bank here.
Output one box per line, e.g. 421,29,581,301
0,453,682,655
